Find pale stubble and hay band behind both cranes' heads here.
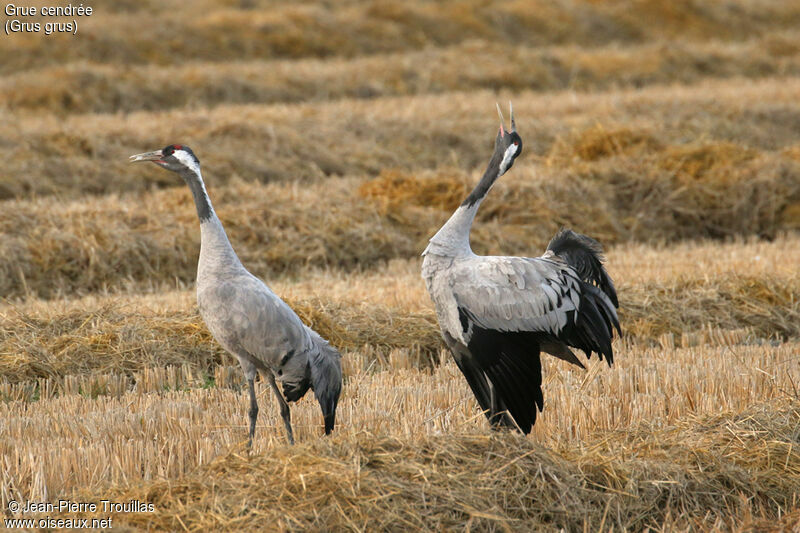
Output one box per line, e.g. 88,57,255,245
0,78,800,199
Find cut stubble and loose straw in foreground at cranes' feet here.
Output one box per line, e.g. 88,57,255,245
0,343,800,529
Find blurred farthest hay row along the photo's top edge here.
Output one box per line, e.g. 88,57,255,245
6,0,800,74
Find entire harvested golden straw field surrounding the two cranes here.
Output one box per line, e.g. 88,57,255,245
0,0,800,531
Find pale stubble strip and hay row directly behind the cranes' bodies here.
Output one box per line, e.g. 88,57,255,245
0,233,800,383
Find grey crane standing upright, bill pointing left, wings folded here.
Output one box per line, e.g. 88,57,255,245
130,144,342,445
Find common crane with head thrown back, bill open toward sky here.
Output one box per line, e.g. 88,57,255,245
422,104,620,435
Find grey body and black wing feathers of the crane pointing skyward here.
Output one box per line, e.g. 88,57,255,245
430,253,619,434
